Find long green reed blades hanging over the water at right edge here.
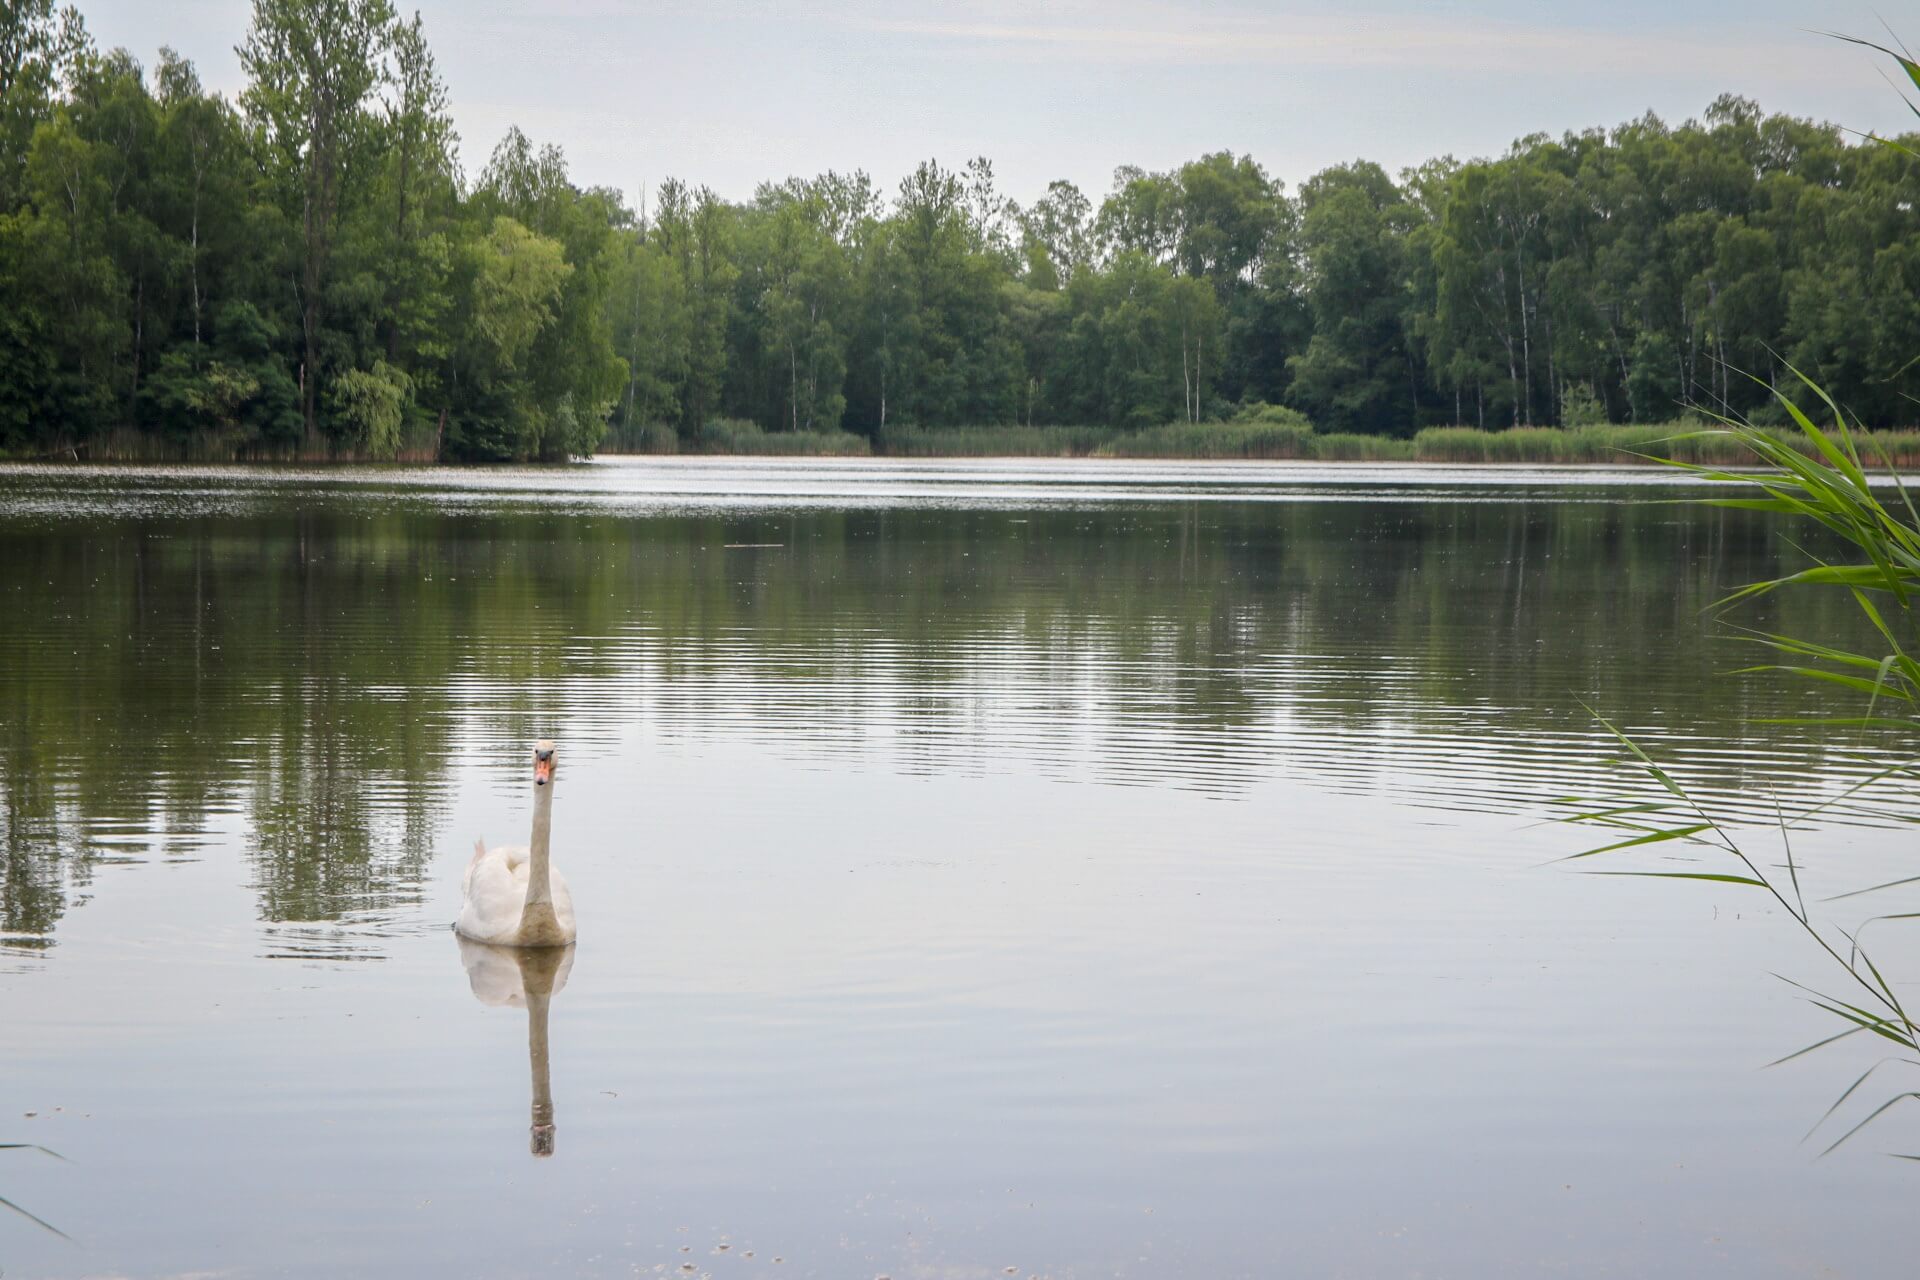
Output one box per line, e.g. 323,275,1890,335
1567,372,1920,1159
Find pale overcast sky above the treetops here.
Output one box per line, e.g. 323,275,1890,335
79,0,1920,201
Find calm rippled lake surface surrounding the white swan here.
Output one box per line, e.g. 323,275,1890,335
0,461,1920,1280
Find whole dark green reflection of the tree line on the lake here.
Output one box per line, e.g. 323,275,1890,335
0,482,1855,935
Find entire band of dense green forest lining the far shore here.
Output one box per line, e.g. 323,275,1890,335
0,0,1920,459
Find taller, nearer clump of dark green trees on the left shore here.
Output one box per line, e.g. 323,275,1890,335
0,0,628,459
